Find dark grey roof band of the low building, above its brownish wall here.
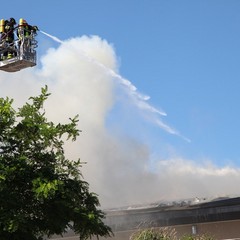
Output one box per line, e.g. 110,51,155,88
106,197,240,231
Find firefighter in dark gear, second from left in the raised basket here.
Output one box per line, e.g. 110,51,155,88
3,18,16,59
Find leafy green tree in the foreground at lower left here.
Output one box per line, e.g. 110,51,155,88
0,86,112,240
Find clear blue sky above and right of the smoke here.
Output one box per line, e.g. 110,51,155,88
1,0,240,166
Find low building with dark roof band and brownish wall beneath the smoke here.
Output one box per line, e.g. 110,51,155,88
51,197,240,240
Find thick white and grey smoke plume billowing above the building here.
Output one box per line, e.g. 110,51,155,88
0,35,240,208
